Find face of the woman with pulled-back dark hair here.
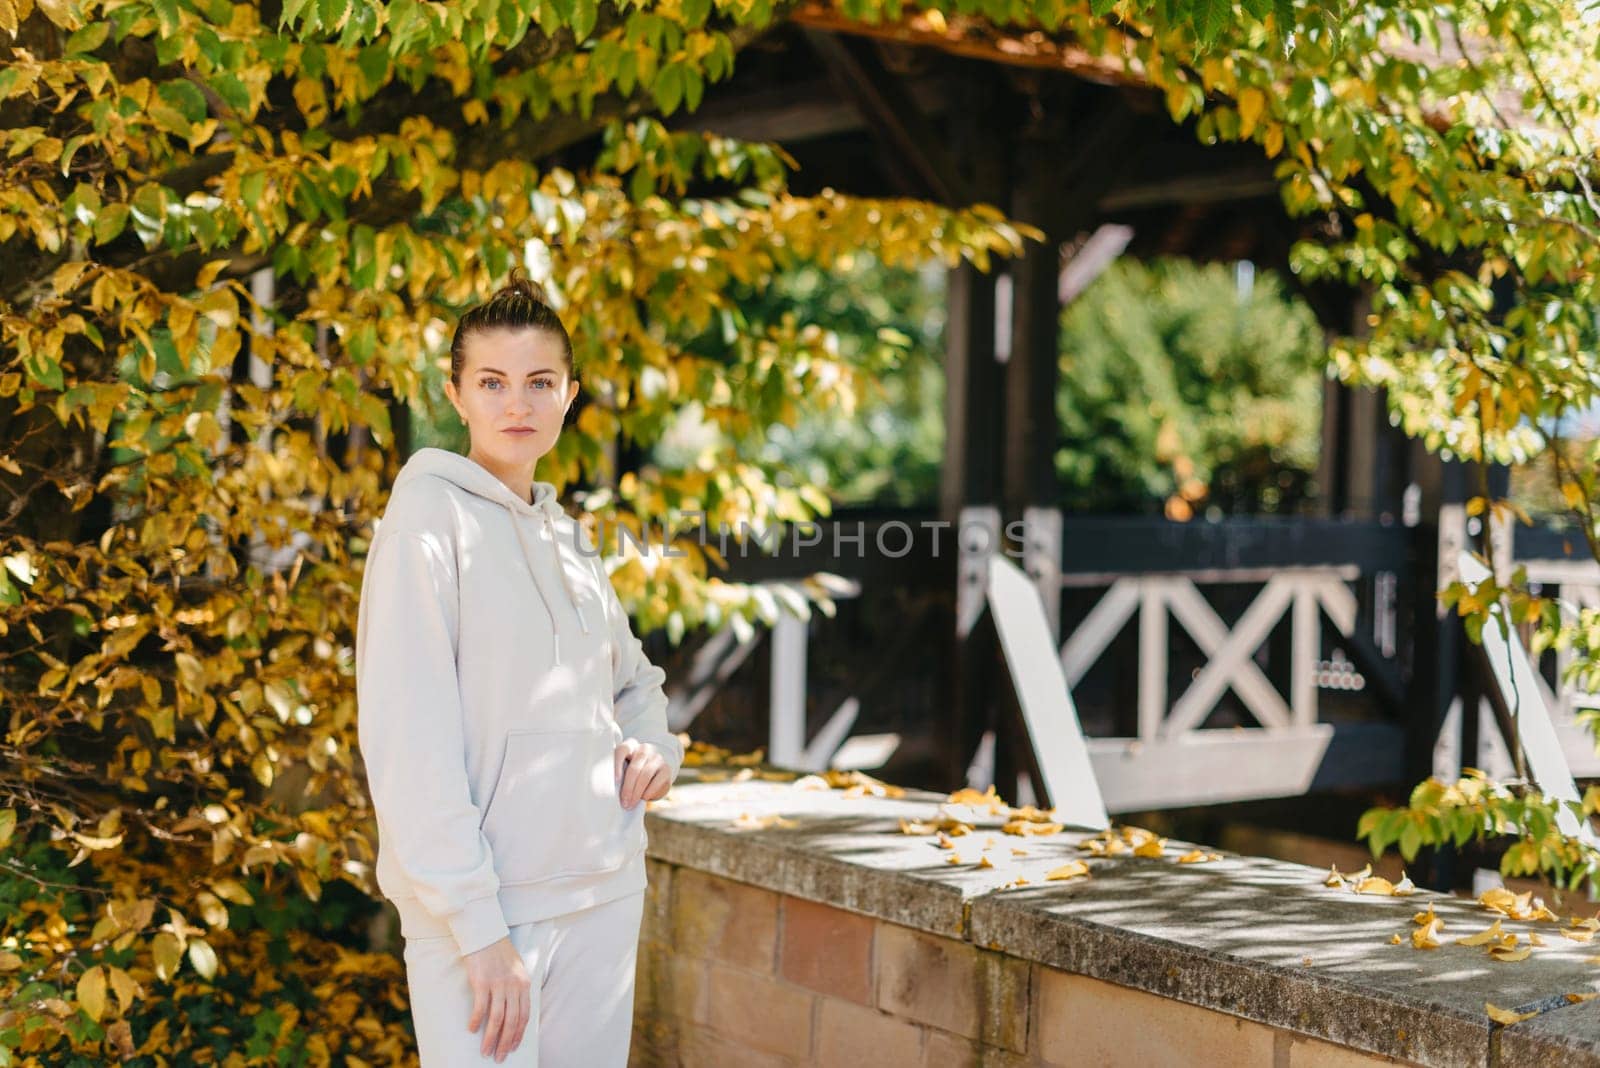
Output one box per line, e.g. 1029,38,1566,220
445,328,578,467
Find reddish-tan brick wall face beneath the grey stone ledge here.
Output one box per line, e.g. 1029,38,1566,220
632,859,1394,1068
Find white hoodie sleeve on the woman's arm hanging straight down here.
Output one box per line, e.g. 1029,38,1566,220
355,531,507,954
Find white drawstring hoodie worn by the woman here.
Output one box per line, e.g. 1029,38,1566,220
355,448,683,954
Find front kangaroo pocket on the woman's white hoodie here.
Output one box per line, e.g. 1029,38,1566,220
483,729,645,883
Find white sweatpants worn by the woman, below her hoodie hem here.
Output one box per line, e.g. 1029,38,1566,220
405,891,645,1068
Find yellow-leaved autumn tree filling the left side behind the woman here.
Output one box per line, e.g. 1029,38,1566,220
0,0,1024,1063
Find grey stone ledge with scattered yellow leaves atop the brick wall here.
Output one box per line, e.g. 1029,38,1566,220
646,769,1600,1068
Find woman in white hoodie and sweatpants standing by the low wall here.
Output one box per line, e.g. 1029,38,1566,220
355,275,683,1068
